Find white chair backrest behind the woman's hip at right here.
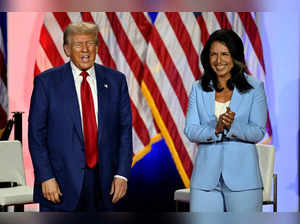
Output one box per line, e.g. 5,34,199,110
256,144,275,201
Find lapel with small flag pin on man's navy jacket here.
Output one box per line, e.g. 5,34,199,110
95,65,110,142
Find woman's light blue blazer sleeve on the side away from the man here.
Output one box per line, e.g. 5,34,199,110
225,82,267,143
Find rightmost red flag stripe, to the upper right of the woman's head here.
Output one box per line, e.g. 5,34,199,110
239,12,266,72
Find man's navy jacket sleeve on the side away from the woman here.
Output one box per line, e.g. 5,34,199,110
28,76,54,183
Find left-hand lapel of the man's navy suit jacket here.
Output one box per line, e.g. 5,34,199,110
62,62,84,142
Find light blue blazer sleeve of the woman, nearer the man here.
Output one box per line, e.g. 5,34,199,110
184,83,222,143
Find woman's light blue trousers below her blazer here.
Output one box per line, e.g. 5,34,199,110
190,176,262,212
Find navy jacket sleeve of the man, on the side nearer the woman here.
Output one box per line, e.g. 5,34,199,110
117,75,133,179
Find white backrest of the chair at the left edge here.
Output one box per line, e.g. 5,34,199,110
0,141,26,185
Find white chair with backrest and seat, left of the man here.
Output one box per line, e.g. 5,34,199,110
0,141,33,212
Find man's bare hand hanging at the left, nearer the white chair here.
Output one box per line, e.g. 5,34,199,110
42,178,62,203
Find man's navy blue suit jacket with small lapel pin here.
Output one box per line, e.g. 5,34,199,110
28,63,132,210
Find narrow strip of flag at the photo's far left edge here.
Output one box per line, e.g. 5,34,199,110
0,12,8,129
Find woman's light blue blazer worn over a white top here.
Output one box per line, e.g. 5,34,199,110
184,75,267,191
